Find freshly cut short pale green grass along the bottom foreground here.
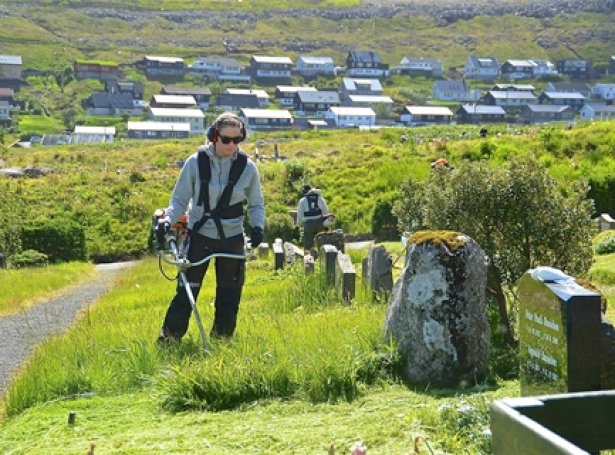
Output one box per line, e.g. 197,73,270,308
0,382,519,455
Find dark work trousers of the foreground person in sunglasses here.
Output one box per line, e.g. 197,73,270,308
162,233,246,339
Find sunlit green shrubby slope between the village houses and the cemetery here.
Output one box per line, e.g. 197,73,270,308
0,122,615,258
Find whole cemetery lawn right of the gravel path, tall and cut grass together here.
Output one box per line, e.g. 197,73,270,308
0,255,518,454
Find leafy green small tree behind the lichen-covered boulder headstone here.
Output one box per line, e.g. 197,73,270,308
394,157,595,343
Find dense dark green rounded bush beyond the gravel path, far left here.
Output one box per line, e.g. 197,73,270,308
21,218,86,263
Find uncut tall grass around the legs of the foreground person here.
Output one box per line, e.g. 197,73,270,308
5,259,397,415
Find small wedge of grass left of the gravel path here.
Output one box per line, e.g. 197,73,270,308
0,262,94,316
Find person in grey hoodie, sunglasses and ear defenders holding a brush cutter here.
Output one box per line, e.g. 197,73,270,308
158,112,265,344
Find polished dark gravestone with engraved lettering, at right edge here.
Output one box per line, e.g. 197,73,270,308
517,267,602,396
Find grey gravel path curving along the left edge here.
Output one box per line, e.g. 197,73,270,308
0,262,134,395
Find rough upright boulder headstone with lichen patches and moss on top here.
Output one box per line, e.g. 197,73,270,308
384,231,490,387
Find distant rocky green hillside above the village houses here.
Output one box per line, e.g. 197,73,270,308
0,0,615,70
